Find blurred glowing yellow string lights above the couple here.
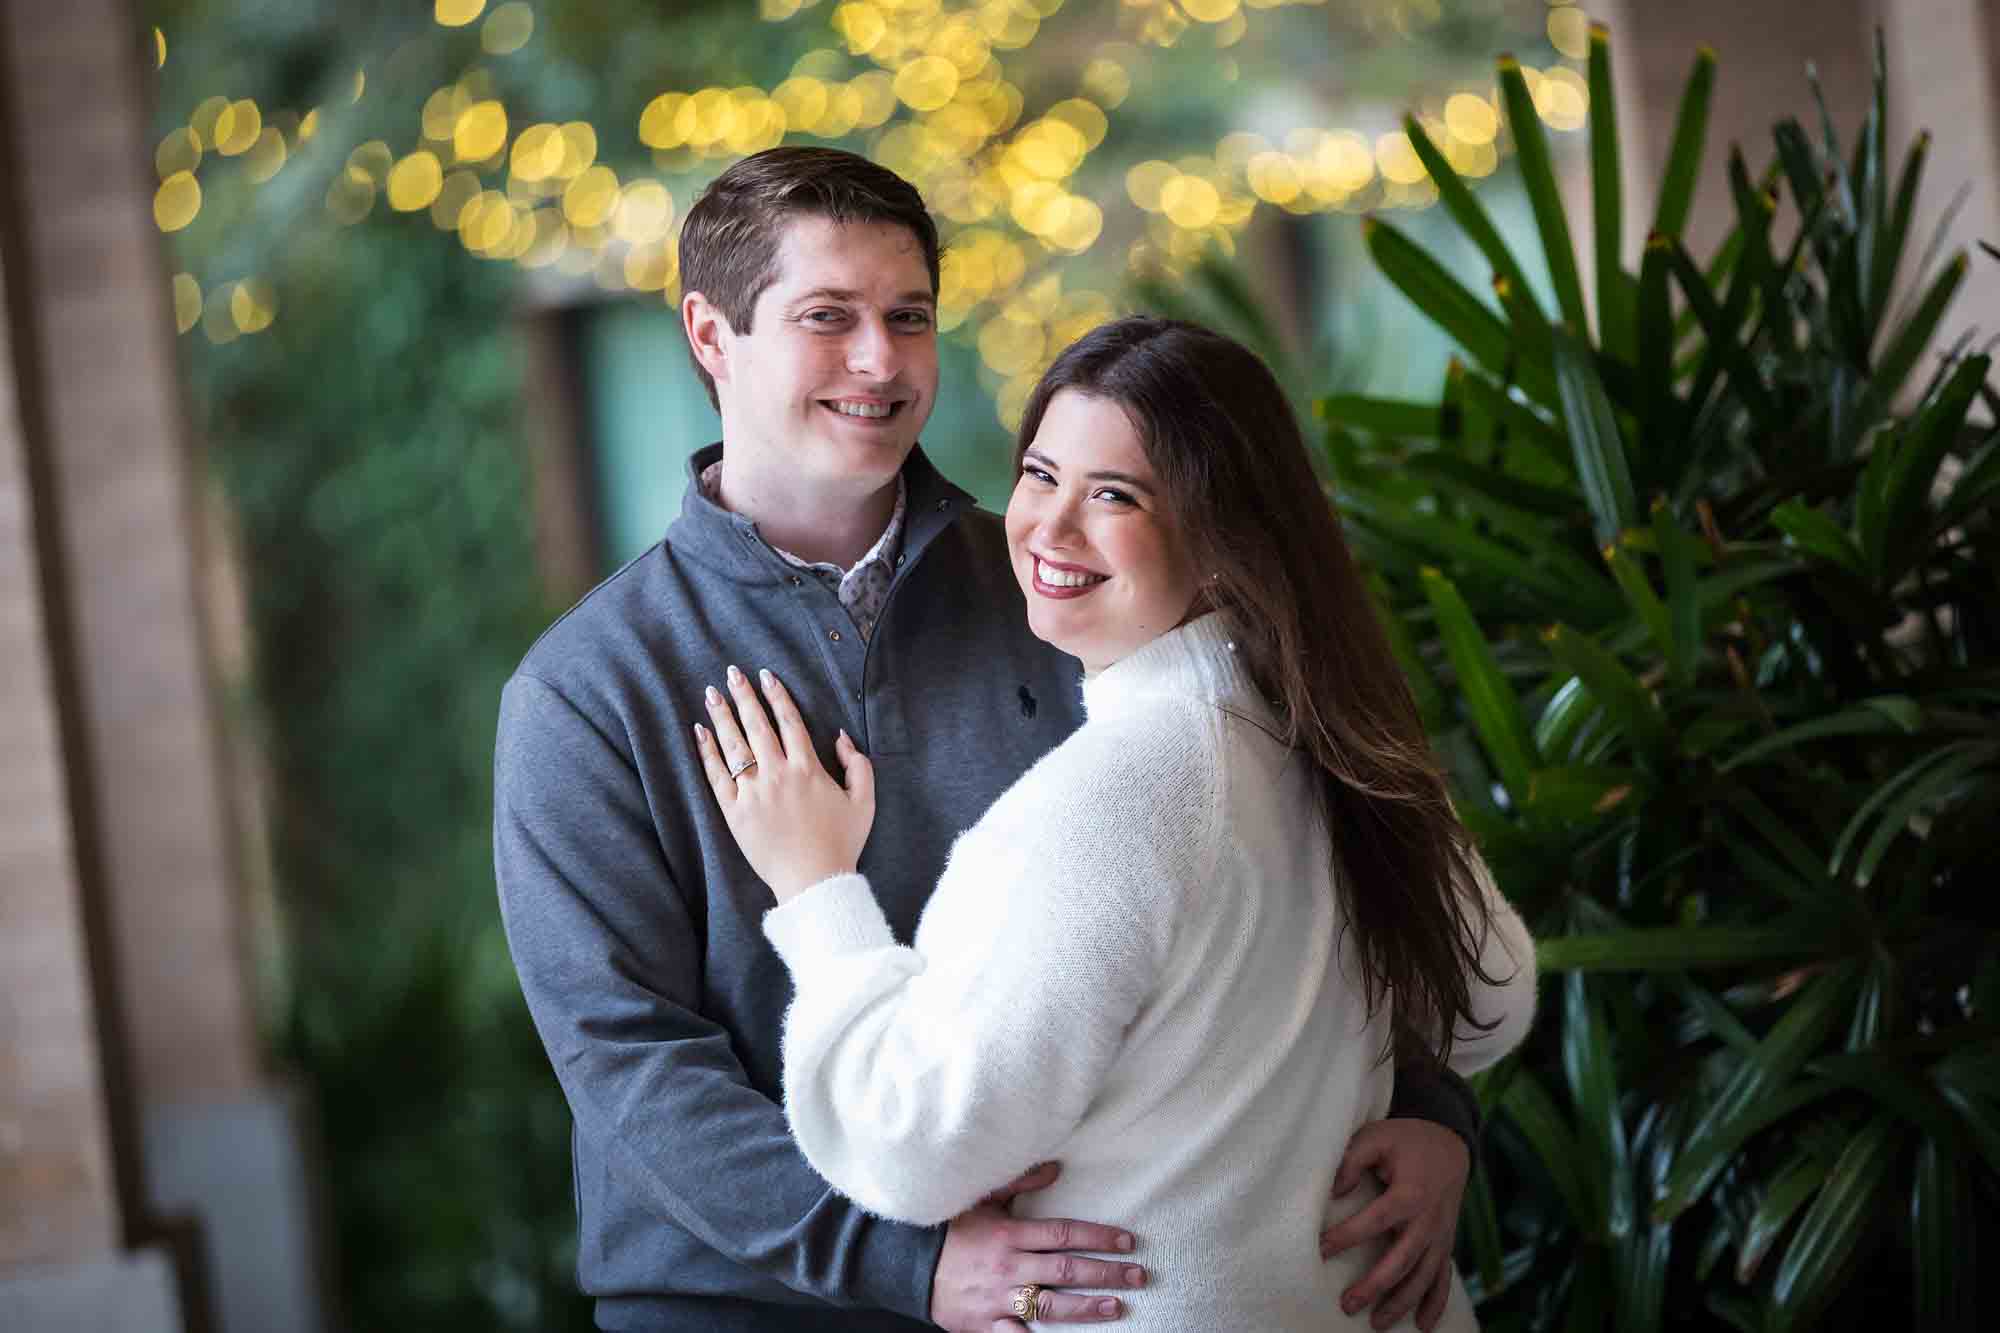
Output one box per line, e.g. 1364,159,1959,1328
154,0,1588,426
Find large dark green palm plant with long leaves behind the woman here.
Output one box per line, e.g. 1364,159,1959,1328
1316,28,2000,1333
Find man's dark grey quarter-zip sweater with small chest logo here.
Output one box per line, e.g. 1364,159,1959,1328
494,446,1470,1333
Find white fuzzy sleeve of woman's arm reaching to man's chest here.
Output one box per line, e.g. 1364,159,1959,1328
764,712,1214,1223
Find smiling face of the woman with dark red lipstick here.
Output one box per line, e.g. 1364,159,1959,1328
1006,388,1200,671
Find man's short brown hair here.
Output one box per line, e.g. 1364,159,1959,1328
680,148,938,406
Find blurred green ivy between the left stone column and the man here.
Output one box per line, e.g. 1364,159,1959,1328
190,226,590,1329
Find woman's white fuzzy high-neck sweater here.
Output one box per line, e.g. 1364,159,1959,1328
764,616,1534,1333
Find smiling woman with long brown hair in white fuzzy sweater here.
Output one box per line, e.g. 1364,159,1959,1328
696,318,1534,1331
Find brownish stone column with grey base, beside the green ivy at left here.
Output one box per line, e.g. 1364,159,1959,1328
0,0,322,1333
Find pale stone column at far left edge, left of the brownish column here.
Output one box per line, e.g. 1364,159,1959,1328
0,75,182,1333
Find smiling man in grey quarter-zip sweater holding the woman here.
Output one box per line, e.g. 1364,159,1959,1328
494,148,1476,1333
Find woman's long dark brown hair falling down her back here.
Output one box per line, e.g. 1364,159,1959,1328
1016,316,1500,1061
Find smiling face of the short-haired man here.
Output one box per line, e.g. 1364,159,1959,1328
712,216,938,488
